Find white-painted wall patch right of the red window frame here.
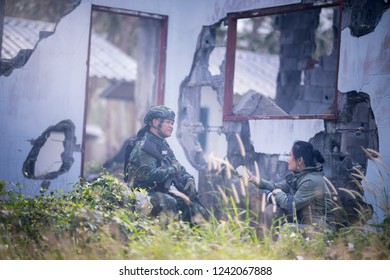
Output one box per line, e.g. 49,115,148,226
338,10,390,221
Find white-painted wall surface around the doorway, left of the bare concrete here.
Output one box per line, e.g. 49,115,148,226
0,0,291,195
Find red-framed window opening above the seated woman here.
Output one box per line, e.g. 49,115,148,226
224,1,340,120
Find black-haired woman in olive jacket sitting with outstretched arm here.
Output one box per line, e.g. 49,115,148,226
248,141,333,236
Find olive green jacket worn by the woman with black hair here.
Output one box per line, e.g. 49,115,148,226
259,165,333,226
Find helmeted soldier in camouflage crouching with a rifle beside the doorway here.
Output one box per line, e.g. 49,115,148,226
125,105,208,224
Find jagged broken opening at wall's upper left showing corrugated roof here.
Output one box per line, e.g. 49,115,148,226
0,0,81,76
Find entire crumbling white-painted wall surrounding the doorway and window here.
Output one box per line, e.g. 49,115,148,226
0,0,390,226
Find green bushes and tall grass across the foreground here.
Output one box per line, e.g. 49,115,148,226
0,166,390,260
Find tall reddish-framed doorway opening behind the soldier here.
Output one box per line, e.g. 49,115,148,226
81,6,167,179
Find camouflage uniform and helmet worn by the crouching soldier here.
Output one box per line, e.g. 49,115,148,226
127,106,209,222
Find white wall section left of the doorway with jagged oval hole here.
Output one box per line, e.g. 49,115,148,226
0,2,91,195
